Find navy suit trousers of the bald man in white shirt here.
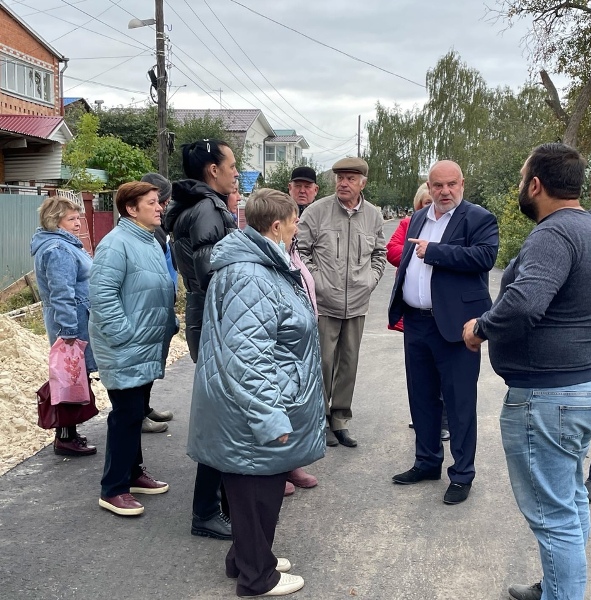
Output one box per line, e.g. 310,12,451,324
404,311,480,483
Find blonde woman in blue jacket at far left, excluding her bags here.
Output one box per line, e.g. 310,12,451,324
31,196,96,456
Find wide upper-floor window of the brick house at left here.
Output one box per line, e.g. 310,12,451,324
0,55,53,104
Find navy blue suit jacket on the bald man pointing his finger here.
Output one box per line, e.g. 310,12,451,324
388,200,499,342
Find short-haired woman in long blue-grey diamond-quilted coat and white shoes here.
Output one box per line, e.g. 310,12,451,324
188,189,325,596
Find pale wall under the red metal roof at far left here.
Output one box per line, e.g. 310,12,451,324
4,144,62,182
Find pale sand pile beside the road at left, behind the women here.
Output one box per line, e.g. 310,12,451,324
0,315,187,475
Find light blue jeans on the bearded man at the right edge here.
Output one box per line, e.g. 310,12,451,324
501,382,591,600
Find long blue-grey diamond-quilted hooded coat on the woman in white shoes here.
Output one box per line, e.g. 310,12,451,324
187,227,326,475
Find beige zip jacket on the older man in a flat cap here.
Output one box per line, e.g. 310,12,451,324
298,194,386,319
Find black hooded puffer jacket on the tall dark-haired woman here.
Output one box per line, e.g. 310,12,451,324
164,179,236,362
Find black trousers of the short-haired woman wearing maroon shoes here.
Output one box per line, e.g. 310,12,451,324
101,382,152,498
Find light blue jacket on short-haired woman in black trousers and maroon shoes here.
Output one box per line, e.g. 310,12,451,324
89,219,176,390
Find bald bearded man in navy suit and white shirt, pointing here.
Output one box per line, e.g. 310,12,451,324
388,160,499,504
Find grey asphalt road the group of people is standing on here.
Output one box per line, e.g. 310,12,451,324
0,222,588,600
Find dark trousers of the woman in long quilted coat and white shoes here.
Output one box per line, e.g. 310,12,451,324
222,473,287,596
